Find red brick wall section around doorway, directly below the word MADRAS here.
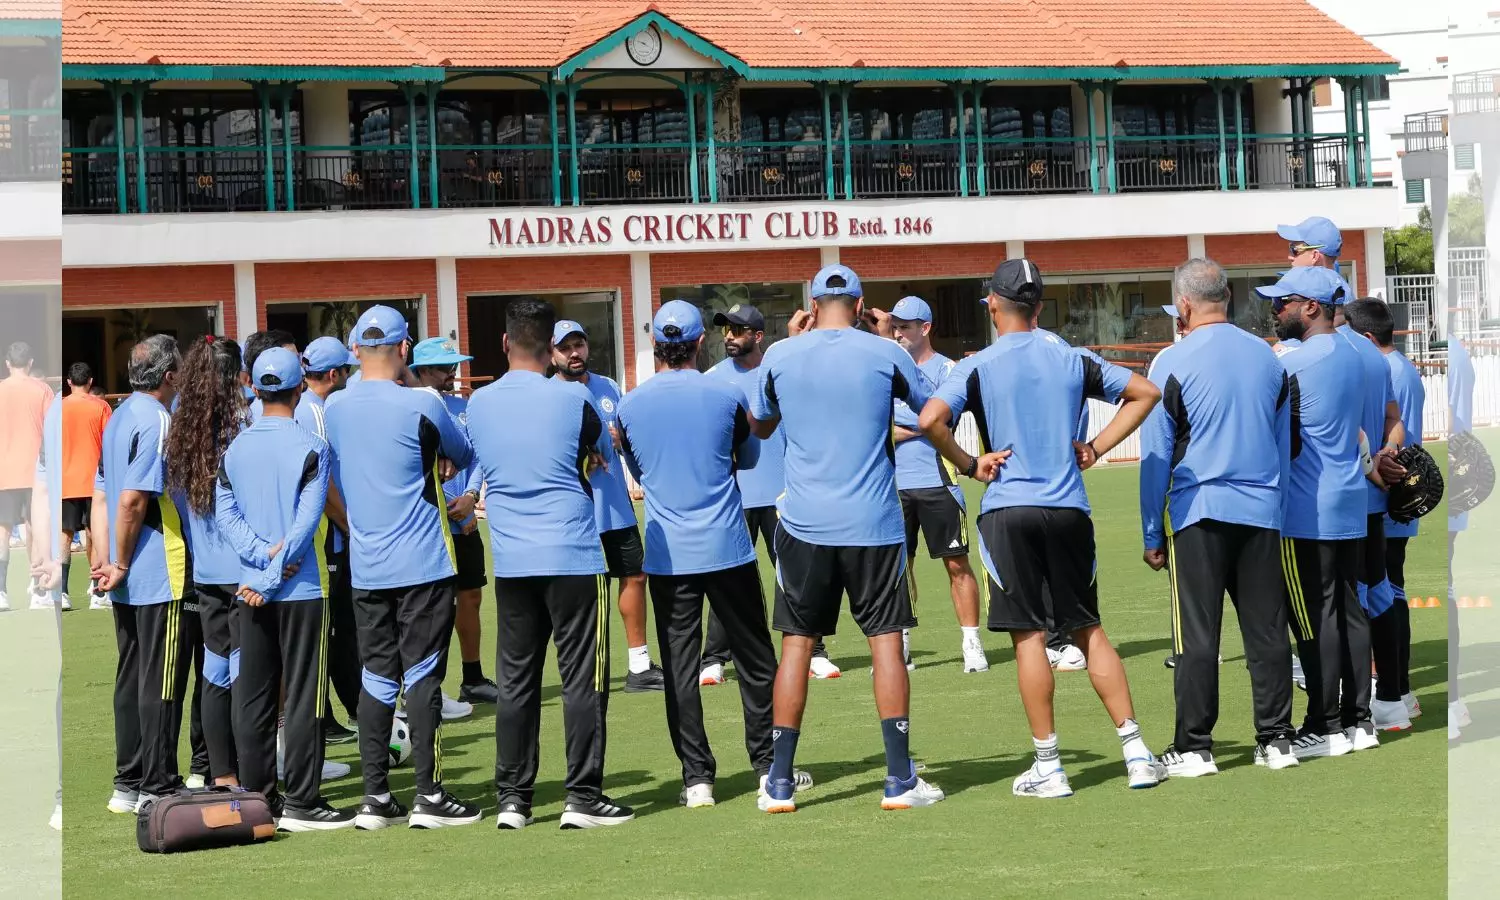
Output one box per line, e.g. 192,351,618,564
458,255,639,381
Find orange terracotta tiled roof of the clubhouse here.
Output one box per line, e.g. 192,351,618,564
58,0,1394,69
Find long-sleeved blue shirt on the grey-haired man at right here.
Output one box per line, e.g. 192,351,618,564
1140,323,1292,549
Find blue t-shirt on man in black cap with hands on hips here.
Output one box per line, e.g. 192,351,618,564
935,332,1130,515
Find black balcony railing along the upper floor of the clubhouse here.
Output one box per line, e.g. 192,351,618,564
62,135,1364,213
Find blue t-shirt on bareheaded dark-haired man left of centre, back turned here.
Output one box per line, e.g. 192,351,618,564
468,369,618,578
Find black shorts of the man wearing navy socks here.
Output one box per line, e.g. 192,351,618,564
773,527,917,638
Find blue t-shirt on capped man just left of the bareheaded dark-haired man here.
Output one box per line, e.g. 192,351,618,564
324,378,474,591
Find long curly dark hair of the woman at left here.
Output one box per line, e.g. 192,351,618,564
167,338,246,515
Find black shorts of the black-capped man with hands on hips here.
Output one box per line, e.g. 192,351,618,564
980,507,1100,635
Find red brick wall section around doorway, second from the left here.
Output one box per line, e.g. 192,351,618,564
255,260,438,336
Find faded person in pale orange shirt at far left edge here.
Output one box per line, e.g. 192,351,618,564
0,341,53,612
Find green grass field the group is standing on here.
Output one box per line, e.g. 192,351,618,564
43,467,1452,900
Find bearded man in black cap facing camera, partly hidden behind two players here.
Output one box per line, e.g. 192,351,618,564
698,303,842,686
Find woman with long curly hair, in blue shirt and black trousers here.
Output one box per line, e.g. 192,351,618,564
167,336,249,785
